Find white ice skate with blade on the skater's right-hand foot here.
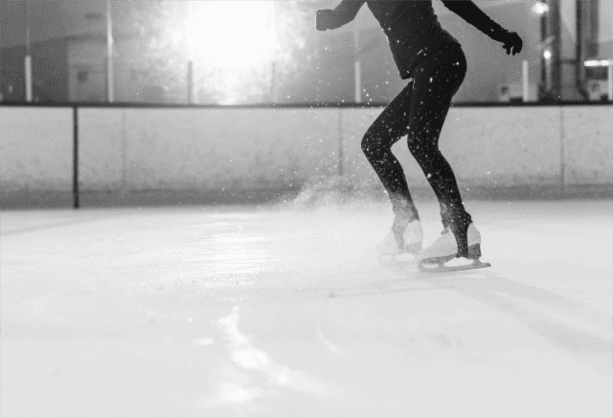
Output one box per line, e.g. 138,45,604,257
417,223,490,272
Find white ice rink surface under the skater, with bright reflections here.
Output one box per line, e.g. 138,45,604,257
0,200,613,417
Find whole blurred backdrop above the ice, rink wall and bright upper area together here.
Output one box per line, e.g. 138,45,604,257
0,0,613,207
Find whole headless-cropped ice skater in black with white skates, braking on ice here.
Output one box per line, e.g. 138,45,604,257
316,0,523,271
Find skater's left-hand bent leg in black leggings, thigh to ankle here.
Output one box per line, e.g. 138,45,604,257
362,82,419,224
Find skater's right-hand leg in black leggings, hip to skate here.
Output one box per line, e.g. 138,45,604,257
408,47,471,254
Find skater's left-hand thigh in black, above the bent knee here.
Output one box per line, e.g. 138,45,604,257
365,82,413,146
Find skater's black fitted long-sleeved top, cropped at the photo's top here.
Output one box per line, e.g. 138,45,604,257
331,0,508,79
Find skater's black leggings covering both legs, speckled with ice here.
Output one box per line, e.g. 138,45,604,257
362,45,471,227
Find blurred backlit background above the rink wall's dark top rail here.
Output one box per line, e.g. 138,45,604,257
0,0,613,105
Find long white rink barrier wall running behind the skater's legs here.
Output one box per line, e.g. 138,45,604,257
0,103,613,207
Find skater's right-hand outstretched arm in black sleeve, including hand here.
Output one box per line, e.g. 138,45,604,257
441,0,523,55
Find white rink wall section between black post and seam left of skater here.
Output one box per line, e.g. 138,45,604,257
79,108,338,191
